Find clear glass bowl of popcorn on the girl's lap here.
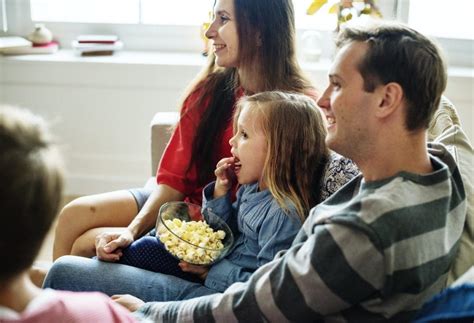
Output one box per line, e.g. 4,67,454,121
156,202,234,265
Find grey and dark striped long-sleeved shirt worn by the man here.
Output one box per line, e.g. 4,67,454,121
135,144,466,322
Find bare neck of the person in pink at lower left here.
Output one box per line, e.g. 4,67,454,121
0,272,41,313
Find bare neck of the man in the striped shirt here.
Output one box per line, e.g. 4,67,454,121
354,133,433,181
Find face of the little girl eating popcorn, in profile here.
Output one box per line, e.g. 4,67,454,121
229,105,267,190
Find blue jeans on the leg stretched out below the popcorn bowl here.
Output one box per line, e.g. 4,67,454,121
43,256,217,302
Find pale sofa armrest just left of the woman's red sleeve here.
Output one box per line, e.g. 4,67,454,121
150,112,179,176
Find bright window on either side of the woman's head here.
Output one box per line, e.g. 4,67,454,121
23,0,336,51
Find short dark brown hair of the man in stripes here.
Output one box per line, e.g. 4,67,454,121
336,23,447,130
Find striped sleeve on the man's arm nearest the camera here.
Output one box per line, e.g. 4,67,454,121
140,224,384,322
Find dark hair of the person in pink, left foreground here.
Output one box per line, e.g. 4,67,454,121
0,106,63,283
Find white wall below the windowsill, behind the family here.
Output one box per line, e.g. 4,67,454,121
0,51,474,195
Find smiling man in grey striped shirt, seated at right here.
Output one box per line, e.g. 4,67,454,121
119,24,466,322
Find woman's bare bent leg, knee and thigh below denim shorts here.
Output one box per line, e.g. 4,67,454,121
53,190,138,259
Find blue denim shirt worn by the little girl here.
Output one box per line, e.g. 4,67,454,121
202,182,301,292
